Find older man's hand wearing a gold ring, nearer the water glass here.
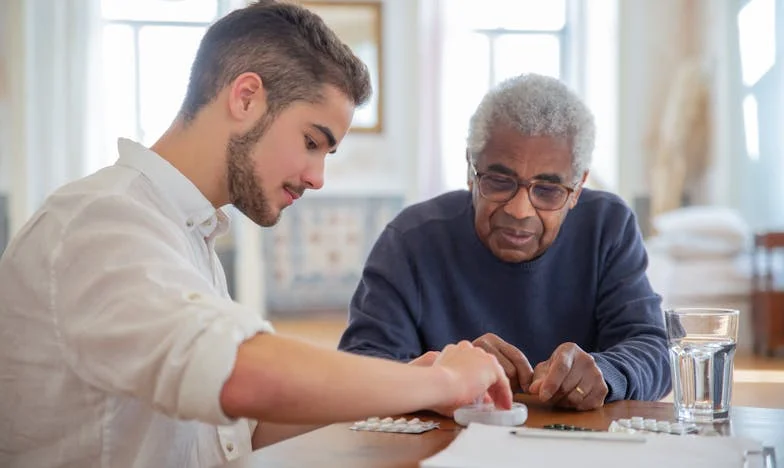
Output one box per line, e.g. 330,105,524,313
529,343,609,411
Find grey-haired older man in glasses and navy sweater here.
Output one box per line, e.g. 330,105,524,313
340,75,670,410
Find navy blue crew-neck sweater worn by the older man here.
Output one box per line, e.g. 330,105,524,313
339,189,671,401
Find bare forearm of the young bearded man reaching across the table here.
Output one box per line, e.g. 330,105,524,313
221,335,452,424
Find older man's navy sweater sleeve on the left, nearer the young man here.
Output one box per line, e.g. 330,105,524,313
338,226,423,361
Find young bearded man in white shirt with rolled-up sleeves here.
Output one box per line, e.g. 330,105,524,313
0,1,511,467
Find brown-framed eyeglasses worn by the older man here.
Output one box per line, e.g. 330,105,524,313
471,164,575,211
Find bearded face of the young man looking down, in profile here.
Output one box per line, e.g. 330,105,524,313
227,86,354,226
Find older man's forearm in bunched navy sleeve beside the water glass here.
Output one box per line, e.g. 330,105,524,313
591,336,671,402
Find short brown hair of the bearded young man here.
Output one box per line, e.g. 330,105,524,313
180,0,372,122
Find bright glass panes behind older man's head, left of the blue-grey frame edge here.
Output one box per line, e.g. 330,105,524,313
441,0,570,189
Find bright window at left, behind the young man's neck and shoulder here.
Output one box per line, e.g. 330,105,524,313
101,0,236,164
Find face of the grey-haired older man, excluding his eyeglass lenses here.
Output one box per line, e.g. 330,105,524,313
469,127,582,263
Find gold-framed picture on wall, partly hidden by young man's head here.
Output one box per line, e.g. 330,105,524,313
296,0,384,133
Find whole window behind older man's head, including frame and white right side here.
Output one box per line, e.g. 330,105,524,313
441,0,618,190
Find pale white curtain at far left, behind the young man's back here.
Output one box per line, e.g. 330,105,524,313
2,0,104,232
